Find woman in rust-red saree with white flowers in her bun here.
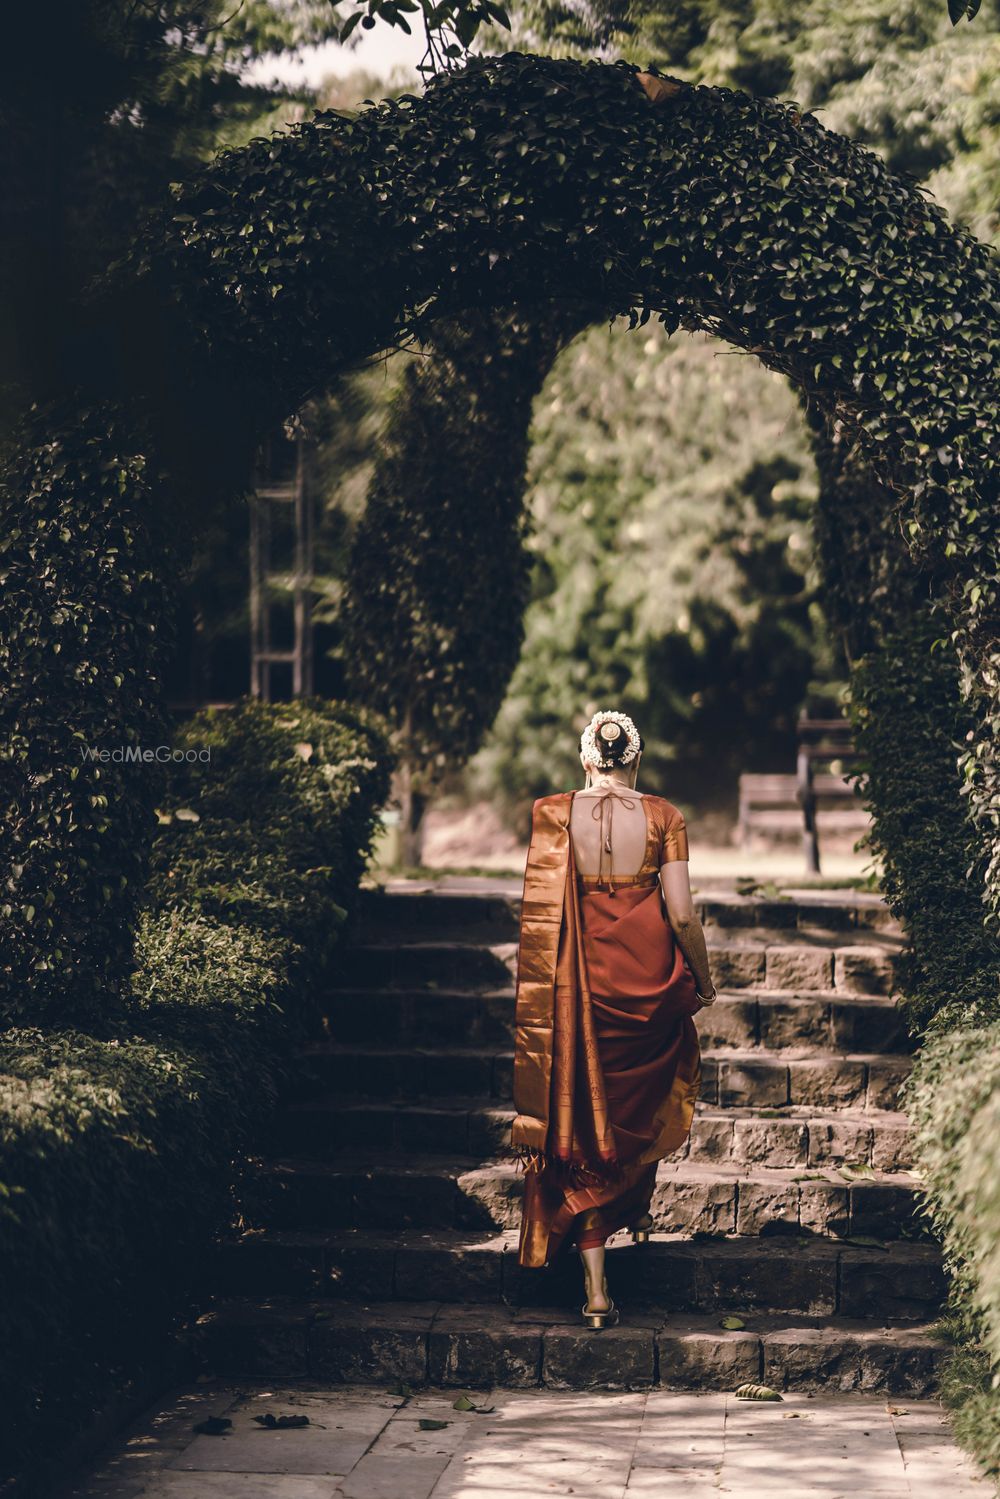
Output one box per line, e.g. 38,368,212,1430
511,711,717,1328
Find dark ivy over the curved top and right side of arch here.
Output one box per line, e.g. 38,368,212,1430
138,54,1000,902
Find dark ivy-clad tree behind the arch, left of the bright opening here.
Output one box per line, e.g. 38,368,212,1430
340,309,577,863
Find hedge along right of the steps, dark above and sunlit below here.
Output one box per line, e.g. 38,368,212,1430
850,613,1000,1478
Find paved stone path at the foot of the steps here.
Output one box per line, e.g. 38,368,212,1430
63,1382,996,1499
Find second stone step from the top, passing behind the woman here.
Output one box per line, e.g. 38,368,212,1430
336,928,901,994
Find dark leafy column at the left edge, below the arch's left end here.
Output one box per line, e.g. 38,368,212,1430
0,406,171,1031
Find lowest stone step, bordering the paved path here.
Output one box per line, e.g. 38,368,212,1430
193,1298,951,1396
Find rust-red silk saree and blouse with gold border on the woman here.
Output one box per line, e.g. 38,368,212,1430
511,791,702,1267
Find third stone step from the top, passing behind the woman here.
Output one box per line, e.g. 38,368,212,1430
324,988,913,1055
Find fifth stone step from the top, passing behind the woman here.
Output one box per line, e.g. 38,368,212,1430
271,1097,913,1171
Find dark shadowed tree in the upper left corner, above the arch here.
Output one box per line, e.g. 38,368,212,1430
0,0,339,439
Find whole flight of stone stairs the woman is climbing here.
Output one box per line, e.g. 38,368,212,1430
196,881,946,1394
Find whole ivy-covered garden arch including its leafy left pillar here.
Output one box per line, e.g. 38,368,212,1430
0,54,1000,1019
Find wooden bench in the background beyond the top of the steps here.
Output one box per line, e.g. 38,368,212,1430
738,717,867,874
